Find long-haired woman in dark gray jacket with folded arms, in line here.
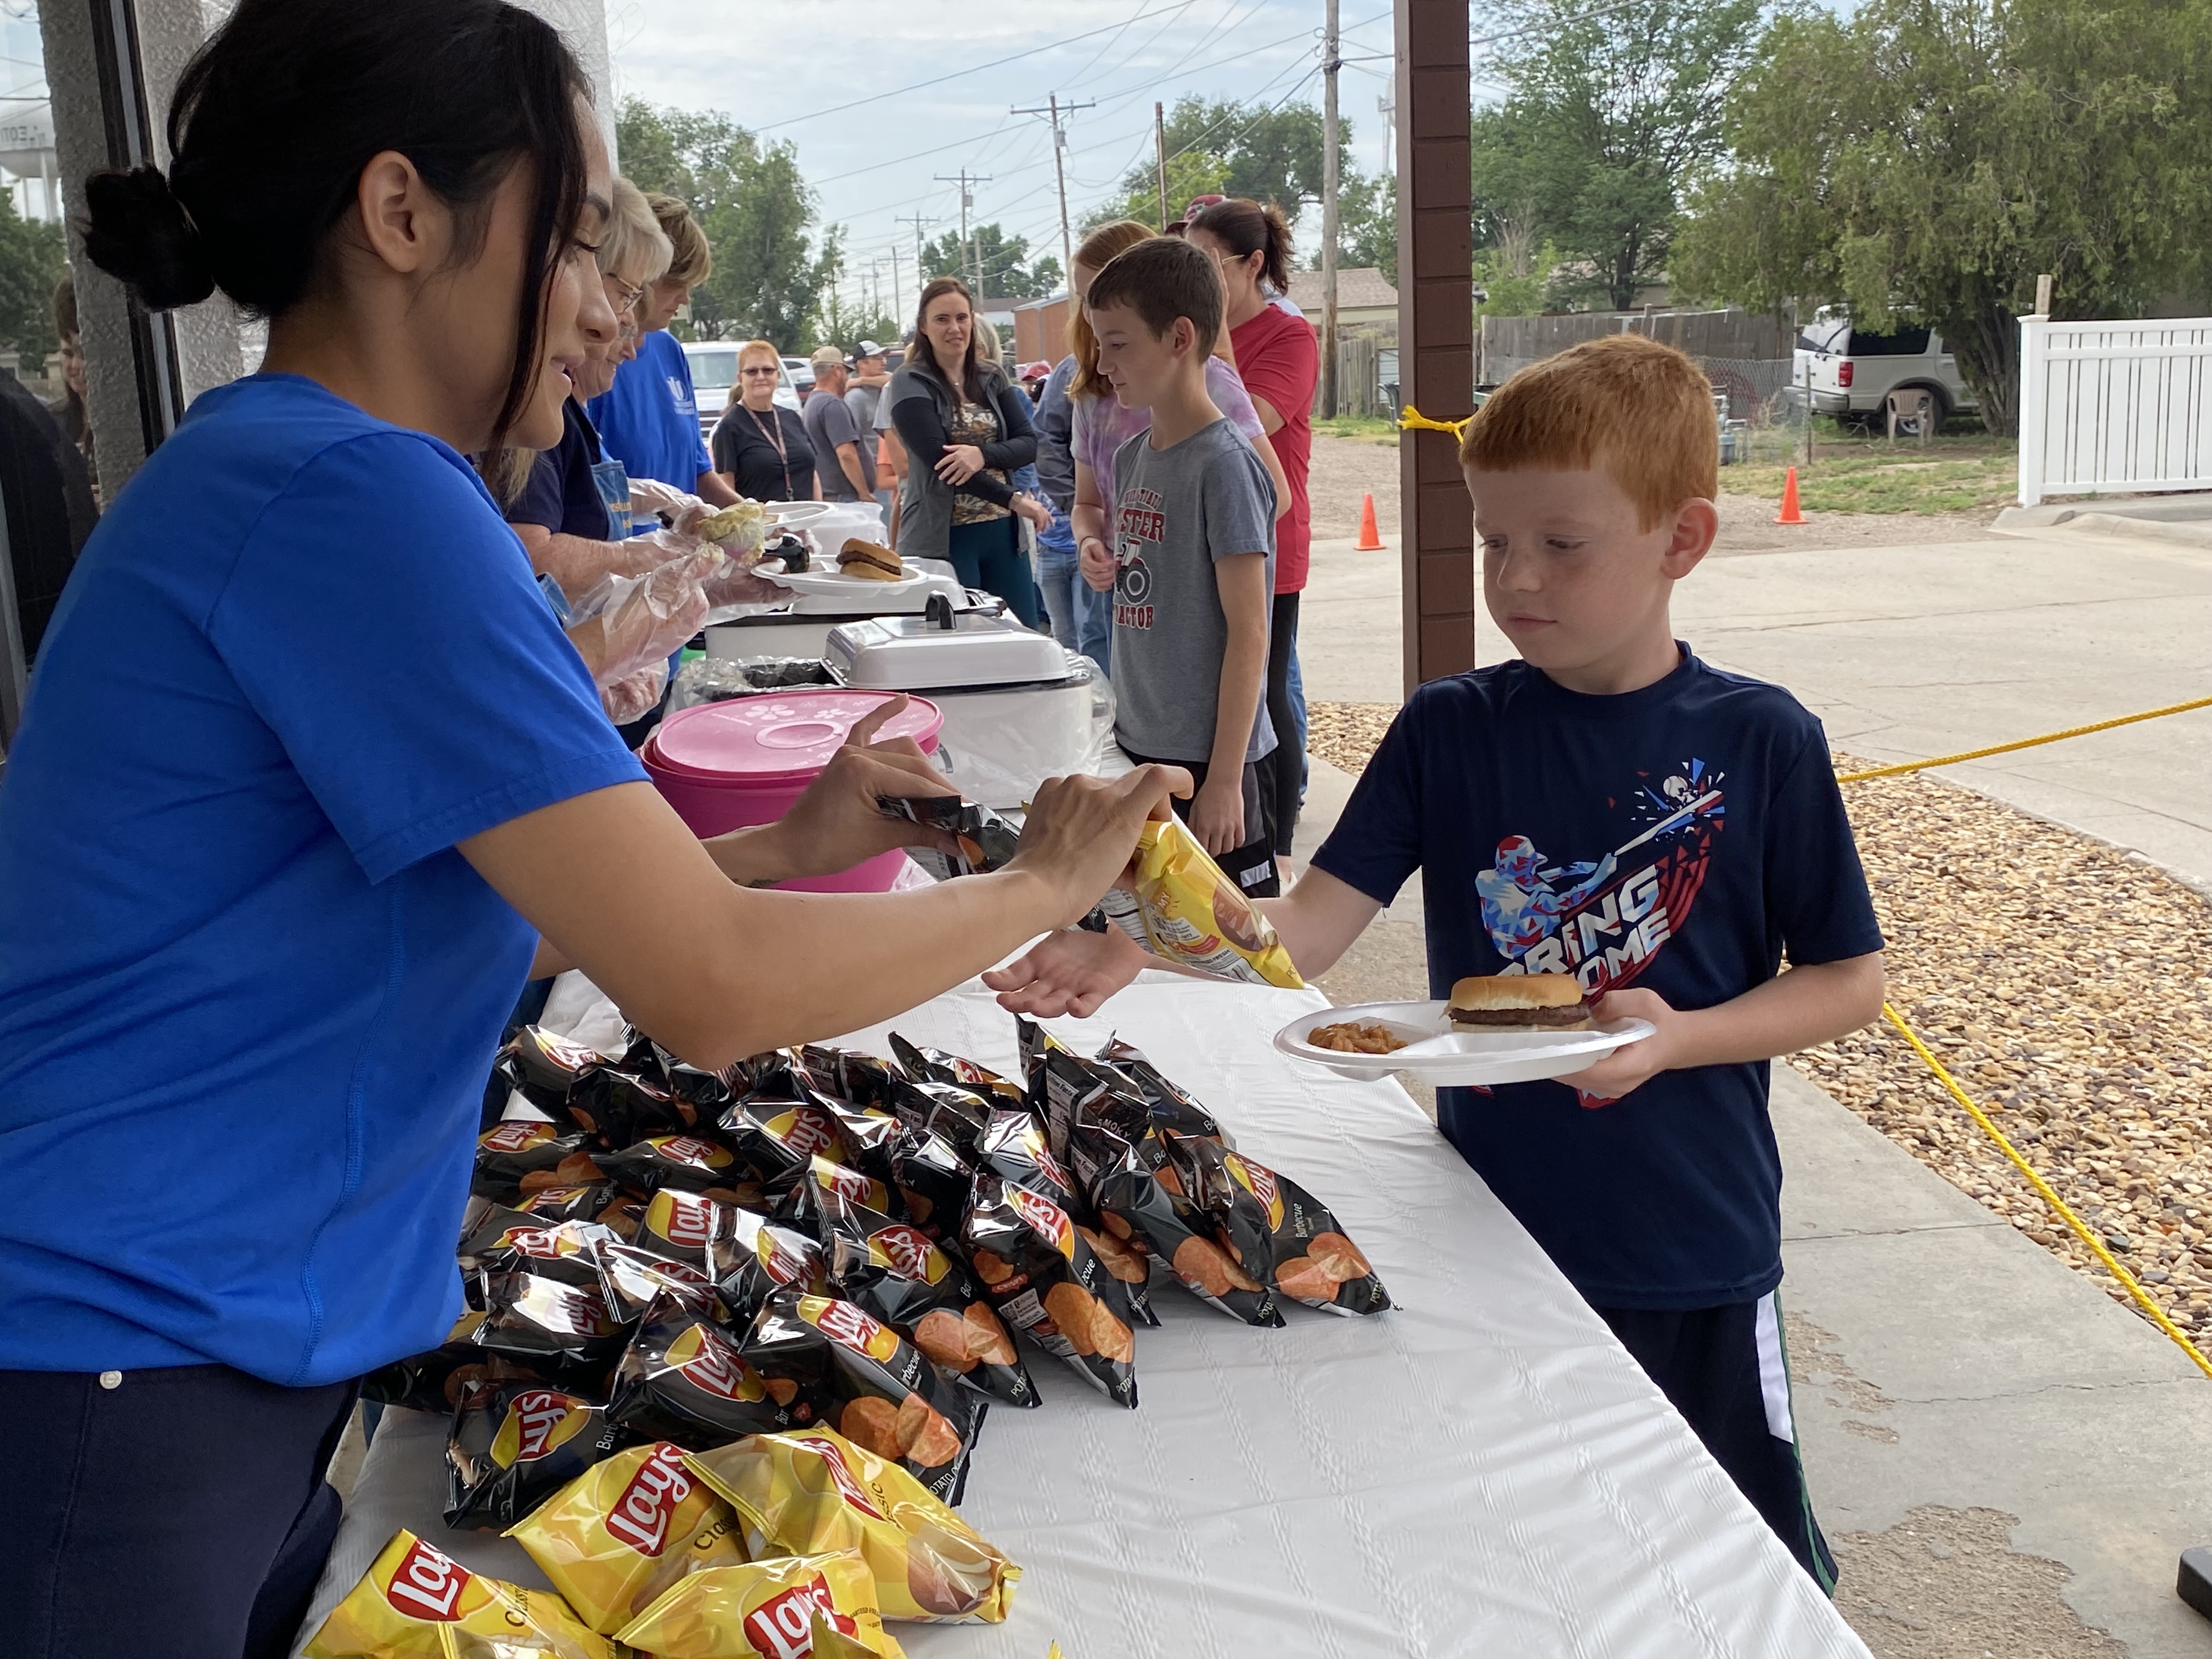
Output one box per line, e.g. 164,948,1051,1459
885,276,1053,628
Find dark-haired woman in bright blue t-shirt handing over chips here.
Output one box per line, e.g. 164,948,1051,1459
0,0,1188,1659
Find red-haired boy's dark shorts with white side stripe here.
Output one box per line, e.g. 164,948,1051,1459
1597,1292,1836,1595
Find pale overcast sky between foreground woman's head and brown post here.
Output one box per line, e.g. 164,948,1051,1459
606,0,1391,314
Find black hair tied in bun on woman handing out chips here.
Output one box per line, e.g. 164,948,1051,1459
84,0,589,433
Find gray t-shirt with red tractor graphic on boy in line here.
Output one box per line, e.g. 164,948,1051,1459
1113,420,1274,761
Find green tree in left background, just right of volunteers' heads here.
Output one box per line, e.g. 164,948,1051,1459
615,97,843,347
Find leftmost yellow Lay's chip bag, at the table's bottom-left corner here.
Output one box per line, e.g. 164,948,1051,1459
301,1528,615,1659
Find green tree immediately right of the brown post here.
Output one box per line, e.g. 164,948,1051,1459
1469,0,1760,309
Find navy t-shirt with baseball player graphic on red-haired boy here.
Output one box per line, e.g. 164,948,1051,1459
1314,646,1882,1310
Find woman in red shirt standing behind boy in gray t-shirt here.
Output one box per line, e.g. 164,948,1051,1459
1183,197,1321,858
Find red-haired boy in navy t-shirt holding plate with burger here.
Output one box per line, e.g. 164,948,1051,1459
986,334,1882,1590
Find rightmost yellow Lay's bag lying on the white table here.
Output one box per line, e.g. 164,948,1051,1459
684,1429,1022,1623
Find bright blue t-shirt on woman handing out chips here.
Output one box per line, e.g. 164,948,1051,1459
0,374,644,1385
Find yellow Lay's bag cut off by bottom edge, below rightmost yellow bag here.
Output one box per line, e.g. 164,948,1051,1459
615,1550,905,1659
